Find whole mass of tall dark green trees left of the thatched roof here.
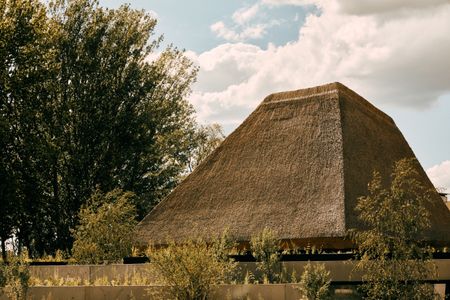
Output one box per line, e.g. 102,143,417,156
0,0,196,255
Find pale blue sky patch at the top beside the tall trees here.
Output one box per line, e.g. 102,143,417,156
100,0,318,53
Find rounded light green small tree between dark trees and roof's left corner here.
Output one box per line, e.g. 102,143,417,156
72,189,136,264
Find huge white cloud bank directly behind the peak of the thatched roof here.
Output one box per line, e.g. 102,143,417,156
192,0,450,128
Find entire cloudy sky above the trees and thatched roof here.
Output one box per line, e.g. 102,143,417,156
100,0,450,192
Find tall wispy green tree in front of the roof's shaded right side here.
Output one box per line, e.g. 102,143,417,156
352,159,435,299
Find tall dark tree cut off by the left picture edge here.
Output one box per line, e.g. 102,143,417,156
0,0,59,257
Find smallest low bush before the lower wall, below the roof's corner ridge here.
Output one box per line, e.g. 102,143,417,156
299,262,331,300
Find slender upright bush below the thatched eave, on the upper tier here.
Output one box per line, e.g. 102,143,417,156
250,228,281,283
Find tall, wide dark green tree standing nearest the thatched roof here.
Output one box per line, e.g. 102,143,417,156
48,0,196,252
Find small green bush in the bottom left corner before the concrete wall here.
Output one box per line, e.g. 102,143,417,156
0,251,30,300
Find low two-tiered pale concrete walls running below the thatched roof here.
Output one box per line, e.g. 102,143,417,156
0,259,450,300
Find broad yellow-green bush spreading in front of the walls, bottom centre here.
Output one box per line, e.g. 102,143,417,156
147,240,236,300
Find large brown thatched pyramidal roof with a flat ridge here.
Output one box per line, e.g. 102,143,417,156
136,83,450,249
